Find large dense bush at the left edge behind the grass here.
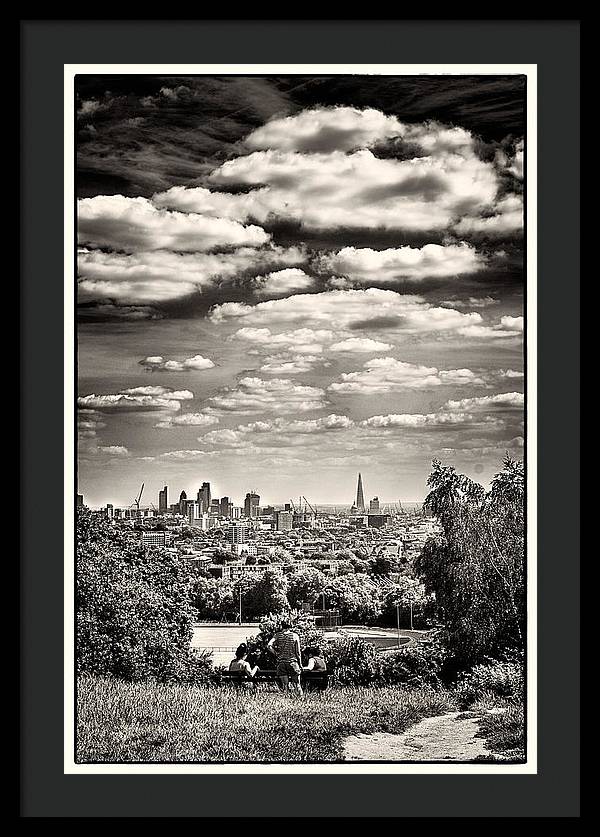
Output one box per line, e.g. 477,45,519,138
76,509,208,681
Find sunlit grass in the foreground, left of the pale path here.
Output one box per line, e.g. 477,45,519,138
77,676,453,763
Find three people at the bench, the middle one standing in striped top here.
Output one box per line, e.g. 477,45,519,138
229,621,327,697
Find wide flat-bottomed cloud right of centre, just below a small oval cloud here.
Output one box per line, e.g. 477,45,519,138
328,357,485,395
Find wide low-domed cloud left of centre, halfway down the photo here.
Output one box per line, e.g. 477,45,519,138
206,377,327,415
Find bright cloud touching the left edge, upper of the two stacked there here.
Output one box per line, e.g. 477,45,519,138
77,195,270,253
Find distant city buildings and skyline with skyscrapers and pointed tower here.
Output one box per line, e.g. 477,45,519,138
77,474,437,581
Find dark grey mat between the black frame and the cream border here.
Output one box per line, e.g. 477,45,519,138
20,20,579,817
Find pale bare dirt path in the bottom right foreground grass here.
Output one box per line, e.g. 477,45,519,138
344,712,492,761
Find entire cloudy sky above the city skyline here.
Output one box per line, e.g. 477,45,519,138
76,75,525,506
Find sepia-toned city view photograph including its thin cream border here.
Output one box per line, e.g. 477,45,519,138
71,64,537,768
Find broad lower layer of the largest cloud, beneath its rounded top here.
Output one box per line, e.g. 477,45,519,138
207,148,499,232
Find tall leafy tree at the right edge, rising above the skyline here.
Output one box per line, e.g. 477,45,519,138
415,456,525,667
